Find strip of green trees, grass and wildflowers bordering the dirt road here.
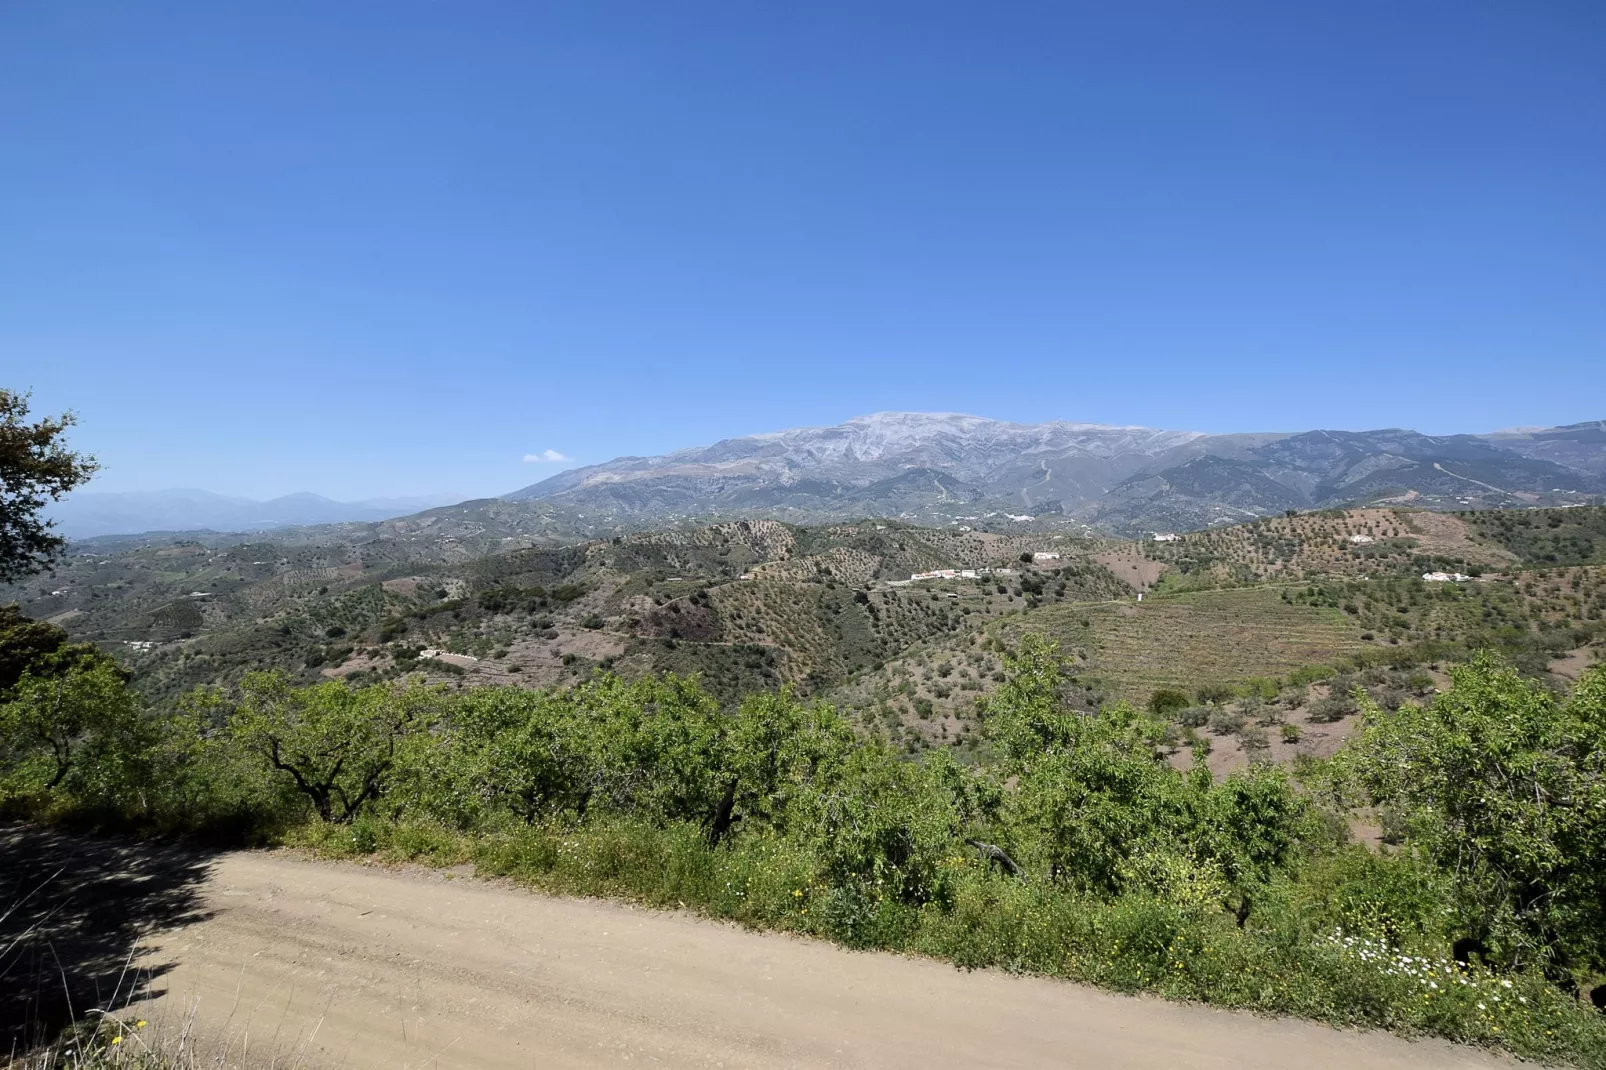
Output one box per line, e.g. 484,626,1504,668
0,626,1606,1067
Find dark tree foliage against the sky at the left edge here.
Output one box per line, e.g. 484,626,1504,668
0,389,100,583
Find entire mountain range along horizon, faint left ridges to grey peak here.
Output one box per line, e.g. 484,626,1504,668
50,413,1606,536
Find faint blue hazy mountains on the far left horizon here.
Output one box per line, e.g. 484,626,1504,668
47,490,456,538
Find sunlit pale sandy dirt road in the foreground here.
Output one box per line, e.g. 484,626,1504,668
122,853,1510,1070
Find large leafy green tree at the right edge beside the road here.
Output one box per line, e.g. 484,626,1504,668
1347,652,1606,978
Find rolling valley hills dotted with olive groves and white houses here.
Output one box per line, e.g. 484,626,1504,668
13,508,1606,768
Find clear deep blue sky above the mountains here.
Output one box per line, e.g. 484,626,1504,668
0,0,1606,498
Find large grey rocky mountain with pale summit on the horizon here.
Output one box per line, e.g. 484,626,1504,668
506,413,1606,533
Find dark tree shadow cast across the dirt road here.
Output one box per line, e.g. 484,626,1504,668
0,824,215,1052
